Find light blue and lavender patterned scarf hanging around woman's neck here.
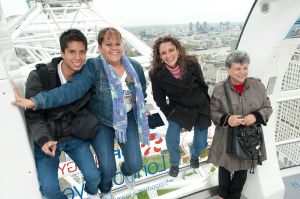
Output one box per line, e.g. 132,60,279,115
102,55,150,144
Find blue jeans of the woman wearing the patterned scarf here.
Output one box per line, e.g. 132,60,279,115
92,111,143,193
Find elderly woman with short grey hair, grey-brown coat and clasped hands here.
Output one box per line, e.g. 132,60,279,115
208,51,272,199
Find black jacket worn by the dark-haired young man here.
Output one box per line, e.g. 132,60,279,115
25,57,91,147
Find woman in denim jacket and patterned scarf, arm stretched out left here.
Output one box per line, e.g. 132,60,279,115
15,27,149,198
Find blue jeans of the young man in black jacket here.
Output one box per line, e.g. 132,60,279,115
34,137,100,199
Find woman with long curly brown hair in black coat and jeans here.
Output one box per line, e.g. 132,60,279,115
149,36,211,177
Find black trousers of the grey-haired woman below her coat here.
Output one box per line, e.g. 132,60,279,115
219,167,247,199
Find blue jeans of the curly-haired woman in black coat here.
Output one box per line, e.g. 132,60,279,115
166,120,207,166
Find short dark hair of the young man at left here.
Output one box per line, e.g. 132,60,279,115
59,29,87,52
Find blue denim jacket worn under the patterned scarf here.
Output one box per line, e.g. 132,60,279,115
31,56,146,127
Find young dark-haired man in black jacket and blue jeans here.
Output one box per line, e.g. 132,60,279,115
25,29,100,199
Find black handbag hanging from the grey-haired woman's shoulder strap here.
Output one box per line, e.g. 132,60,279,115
224,84,263,173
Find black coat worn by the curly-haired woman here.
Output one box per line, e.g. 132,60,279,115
149,61,211,130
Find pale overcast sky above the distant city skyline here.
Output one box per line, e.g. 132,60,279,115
0,0,254,26
